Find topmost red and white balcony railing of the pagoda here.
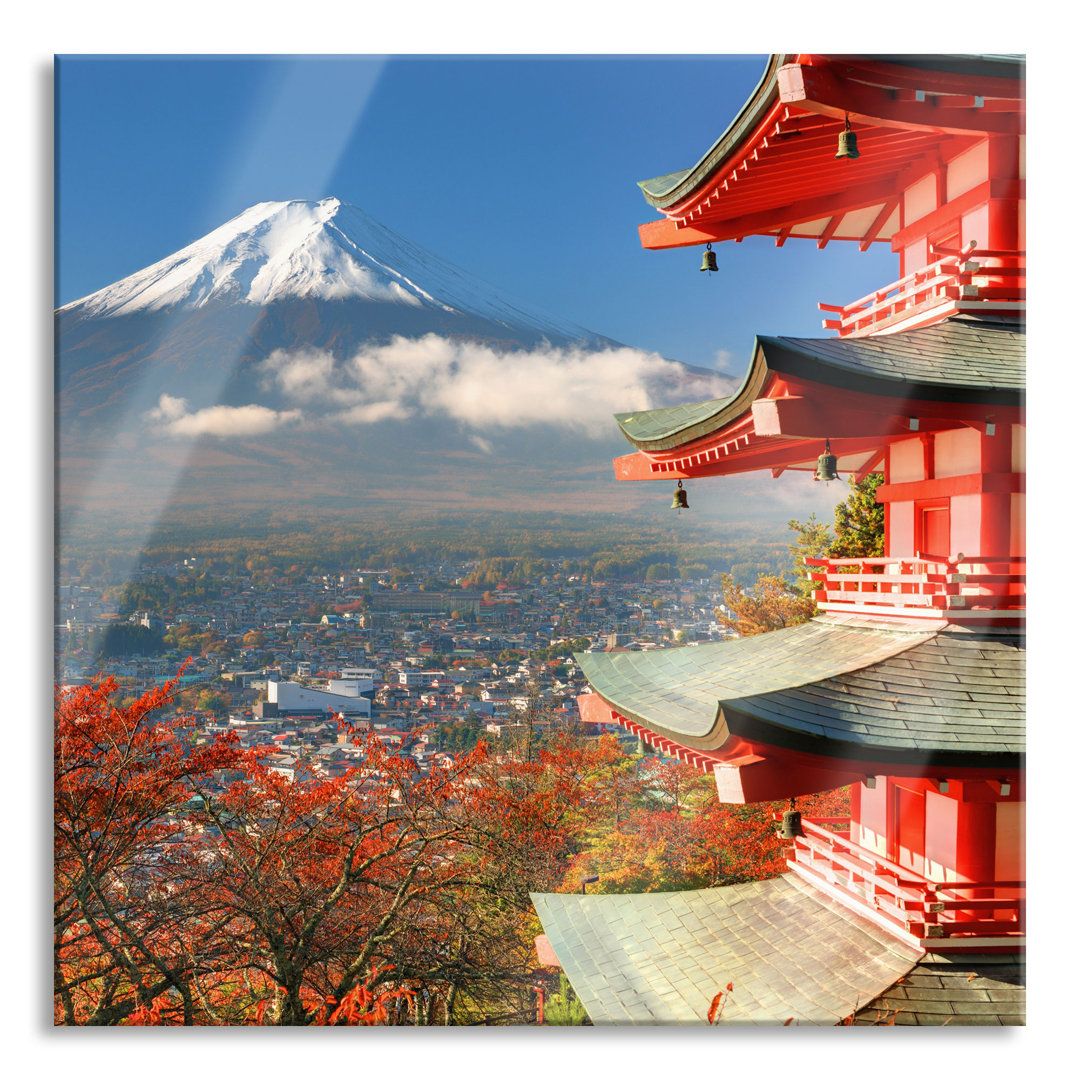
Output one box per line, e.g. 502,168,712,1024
818,243,1027,337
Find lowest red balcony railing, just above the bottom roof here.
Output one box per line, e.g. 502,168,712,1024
777,814,1025,953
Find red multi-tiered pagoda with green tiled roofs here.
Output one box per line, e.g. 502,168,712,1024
534,54,1026,1024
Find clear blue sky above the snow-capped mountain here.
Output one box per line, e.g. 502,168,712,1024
55,53,896,374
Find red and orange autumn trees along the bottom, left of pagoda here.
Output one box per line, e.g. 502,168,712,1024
54,679,851,1026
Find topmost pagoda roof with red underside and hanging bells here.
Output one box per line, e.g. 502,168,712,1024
638,54,1025,247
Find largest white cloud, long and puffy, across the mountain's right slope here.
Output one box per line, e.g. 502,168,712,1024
264,334,732,436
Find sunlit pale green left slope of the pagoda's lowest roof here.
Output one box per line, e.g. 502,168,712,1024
532,875,922,1025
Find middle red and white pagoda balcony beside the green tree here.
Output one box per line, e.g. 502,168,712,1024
806,553,1027,625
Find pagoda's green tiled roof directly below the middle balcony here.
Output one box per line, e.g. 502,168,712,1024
578,616,1025,768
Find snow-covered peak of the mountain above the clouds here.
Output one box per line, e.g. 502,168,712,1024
59,198,584,337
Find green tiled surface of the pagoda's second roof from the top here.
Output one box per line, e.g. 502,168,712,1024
615,314,1026,451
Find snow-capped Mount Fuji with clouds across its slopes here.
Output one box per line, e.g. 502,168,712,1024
55,199,730,531
